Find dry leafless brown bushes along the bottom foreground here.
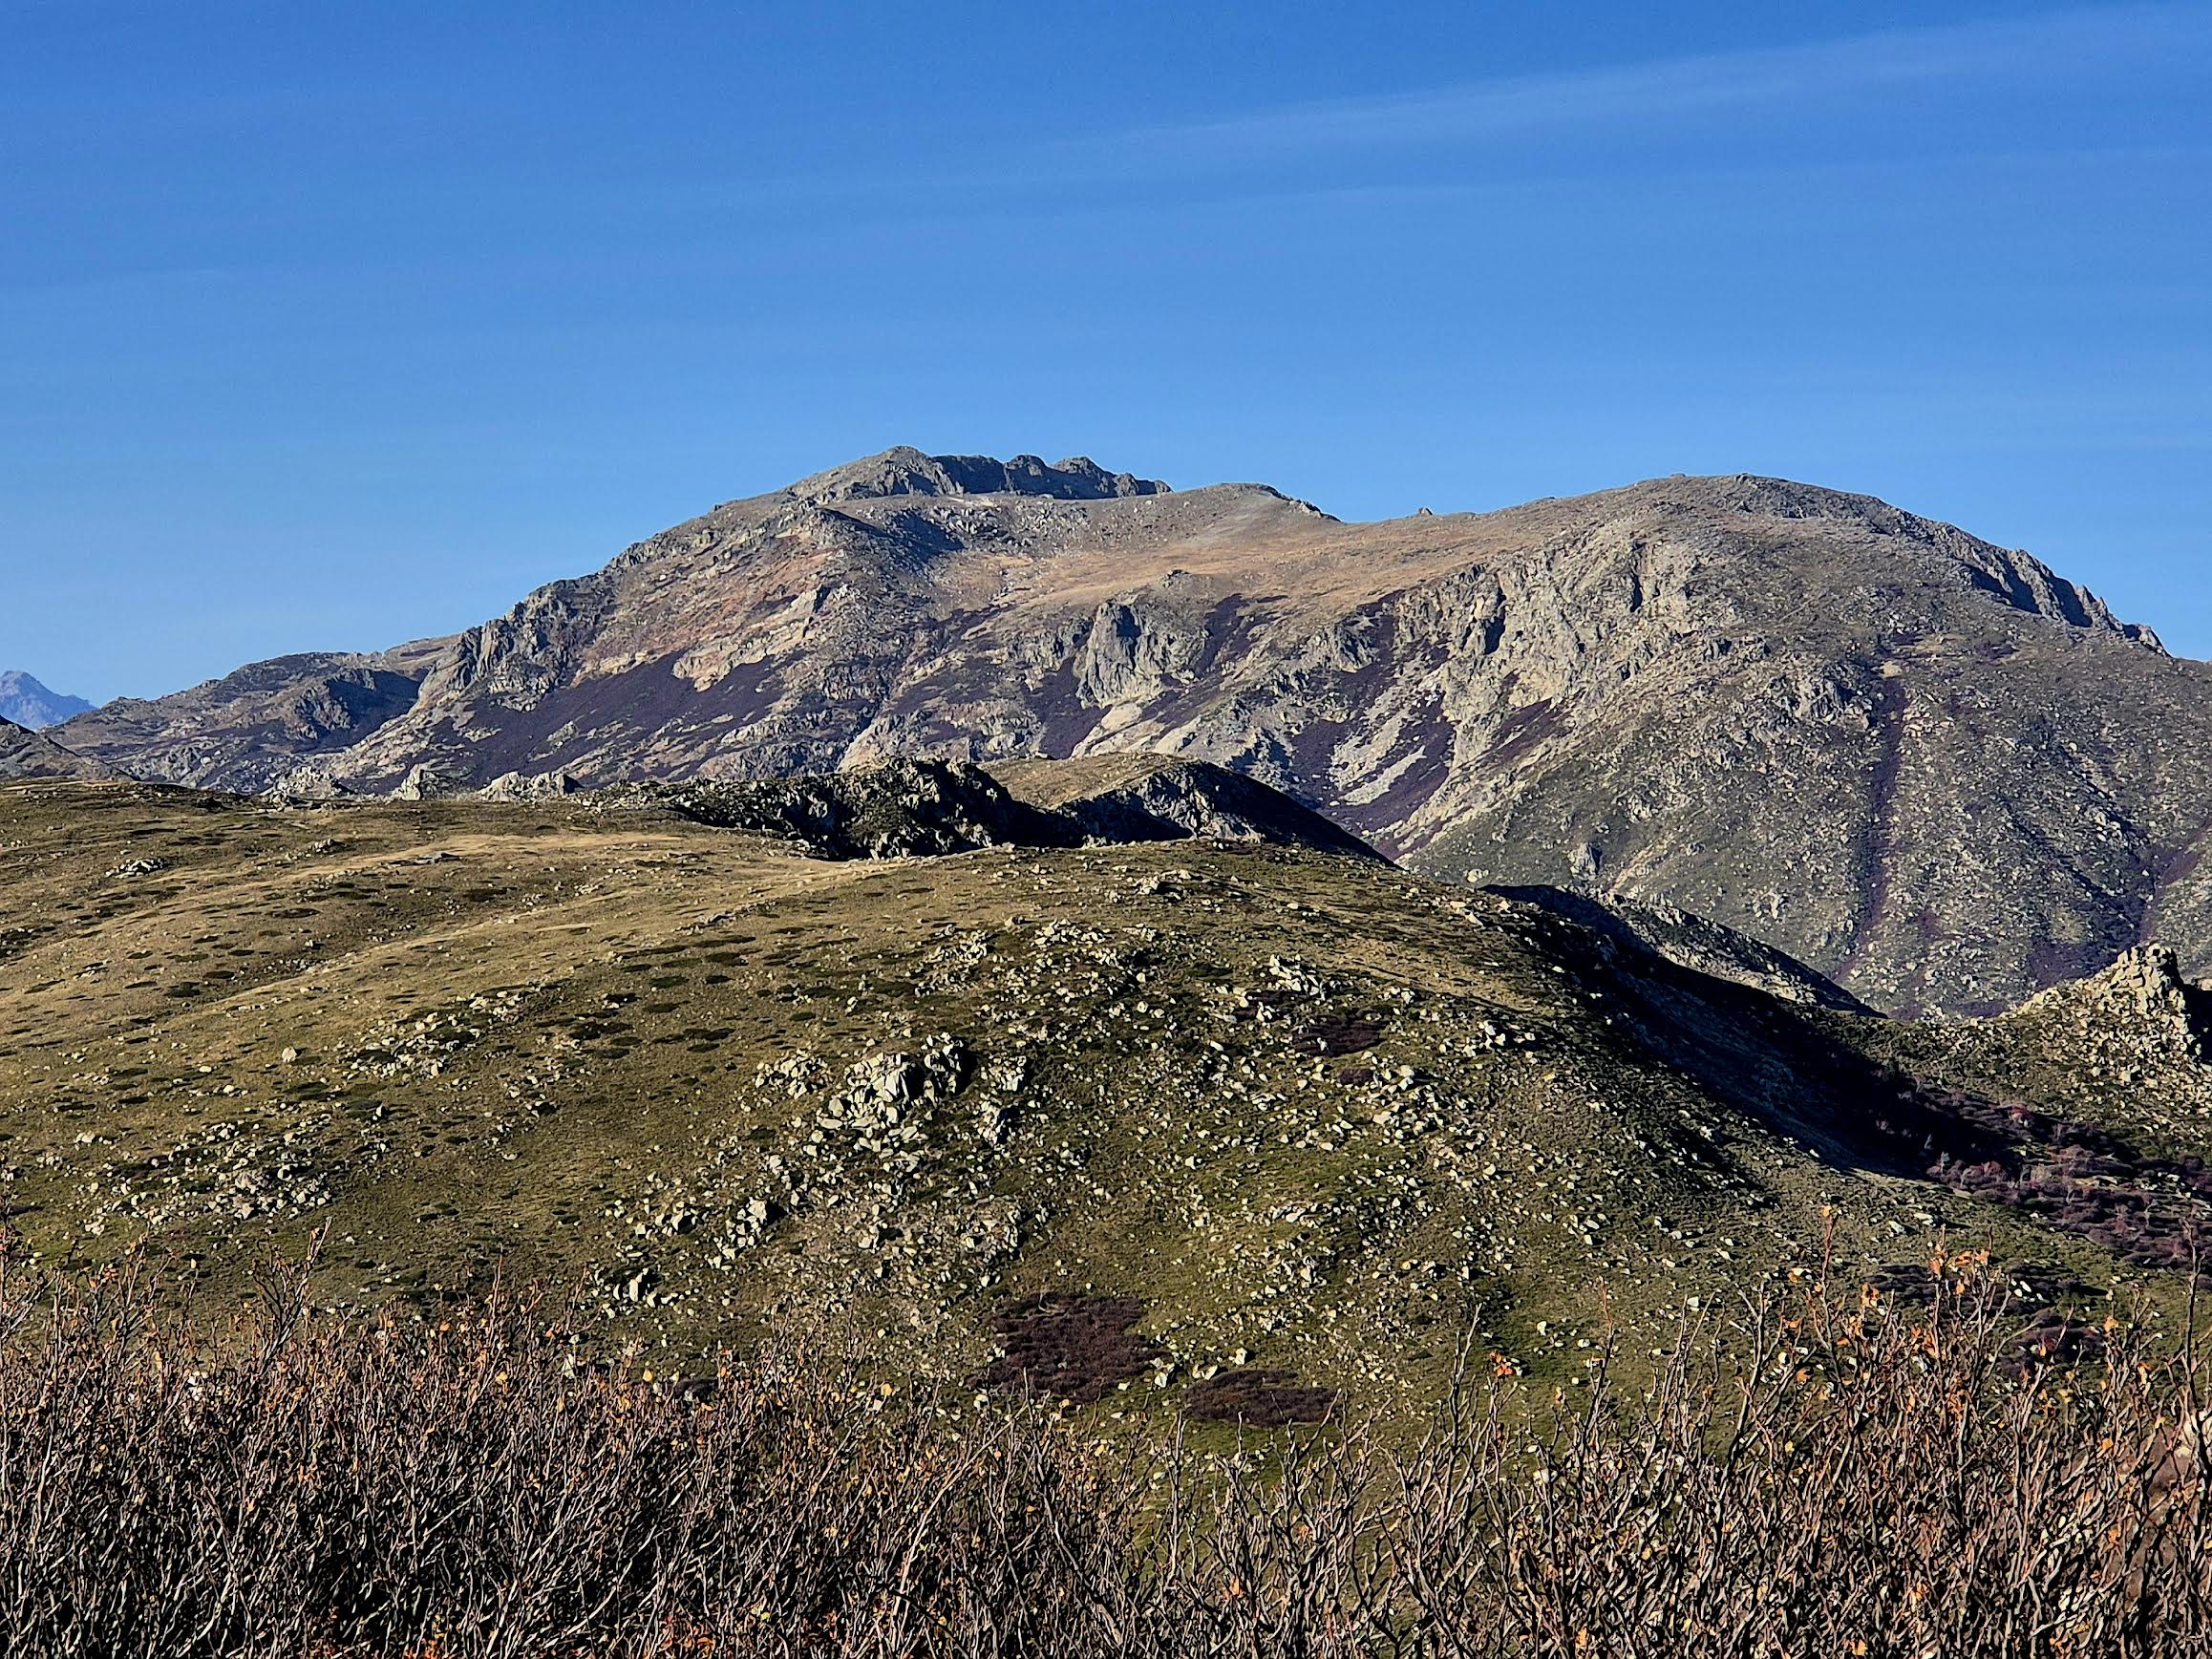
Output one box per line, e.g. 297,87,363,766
0,1272,2212,1659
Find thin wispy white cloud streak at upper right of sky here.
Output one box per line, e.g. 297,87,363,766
1077,2,2212,168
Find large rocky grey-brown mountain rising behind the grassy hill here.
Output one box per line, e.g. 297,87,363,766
60,449,2212,1013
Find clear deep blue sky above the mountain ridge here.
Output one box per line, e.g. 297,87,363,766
0,0,2212,697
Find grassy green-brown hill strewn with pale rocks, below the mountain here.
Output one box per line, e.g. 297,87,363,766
0,761,2212,1420
